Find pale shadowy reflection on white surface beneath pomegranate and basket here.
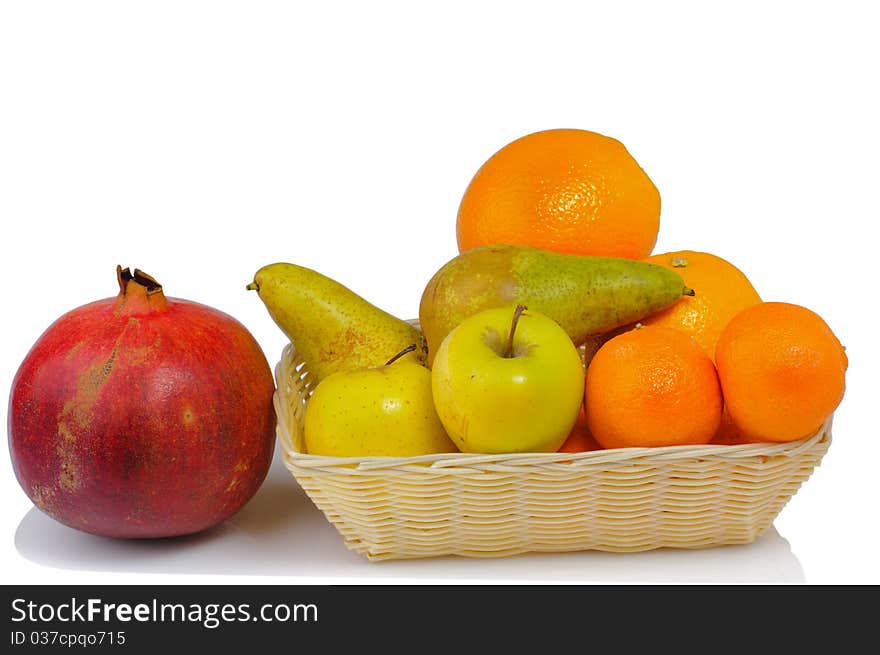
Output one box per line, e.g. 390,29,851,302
15,446,804,584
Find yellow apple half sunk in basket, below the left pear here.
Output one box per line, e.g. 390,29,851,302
303,344,457,457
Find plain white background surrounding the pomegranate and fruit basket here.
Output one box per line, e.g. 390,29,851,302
0,0,880,584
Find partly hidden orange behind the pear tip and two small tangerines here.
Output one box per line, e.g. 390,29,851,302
641,250,761,359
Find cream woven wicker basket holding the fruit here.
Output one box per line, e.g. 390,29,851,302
275,344,831,561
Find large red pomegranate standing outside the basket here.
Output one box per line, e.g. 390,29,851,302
8,267,275,538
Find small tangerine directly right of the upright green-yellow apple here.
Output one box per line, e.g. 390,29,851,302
584,326,722,448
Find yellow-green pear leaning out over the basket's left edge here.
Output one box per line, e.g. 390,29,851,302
247,262,426,381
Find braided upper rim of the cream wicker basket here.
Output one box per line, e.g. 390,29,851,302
274,343,834,471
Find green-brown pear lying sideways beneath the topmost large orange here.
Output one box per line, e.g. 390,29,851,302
419,245,699,362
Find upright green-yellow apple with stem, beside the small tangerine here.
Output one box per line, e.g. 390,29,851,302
431,305,584,453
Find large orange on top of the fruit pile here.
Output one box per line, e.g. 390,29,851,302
457,129,660,259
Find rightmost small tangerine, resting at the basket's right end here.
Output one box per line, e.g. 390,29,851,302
715,302,848,441
